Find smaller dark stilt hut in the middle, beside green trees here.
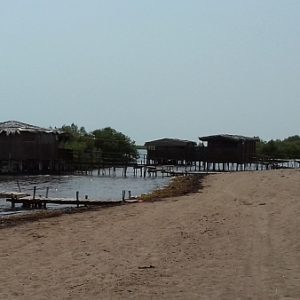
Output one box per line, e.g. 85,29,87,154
145,138,196,165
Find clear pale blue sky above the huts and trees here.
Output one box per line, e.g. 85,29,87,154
0,0,300,144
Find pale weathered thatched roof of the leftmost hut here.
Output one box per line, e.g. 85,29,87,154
0,121,57,135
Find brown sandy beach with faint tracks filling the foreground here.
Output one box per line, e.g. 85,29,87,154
0,170,300,300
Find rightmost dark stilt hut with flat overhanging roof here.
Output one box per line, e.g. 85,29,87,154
199,134,259,164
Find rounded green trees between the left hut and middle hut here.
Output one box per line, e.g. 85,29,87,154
61,124,138,166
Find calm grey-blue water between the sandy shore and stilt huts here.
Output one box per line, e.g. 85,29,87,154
0,169,170,215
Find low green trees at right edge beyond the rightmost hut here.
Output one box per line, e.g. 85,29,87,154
257,135,300,159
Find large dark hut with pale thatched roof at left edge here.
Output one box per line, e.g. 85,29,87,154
0,121,59,173
